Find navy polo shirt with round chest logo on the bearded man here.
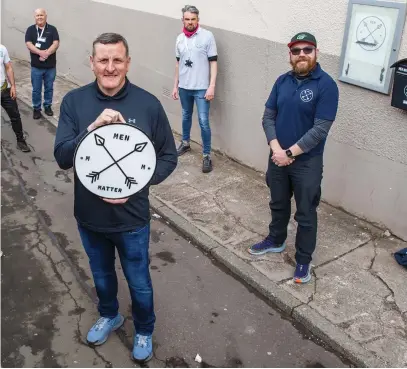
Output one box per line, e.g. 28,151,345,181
266,63,339,160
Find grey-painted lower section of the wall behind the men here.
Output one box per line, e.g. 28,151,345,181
2,0,407,239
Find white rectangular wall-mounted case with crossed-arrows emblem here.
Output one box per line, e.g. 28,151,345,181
339,0,406,94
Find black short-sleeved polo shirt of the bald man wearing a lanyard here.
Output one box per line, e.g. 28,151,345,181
25,23,59,68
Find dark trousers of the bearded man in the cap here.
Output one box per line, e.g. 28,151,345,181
266,155,323,264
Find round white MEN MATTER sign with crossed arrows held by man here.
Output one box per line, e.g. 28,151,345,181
74,123,156,199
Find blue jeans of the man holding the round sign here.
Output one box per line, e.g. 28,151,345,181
78,224,155,335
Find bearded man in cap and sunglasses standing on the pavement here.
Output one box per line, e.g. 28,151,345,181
248,32,339,283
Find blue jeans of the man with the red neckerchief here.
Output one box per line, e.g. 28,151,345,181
179,88,211,155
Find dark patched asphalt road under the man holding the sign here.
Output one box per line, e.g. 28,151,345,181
1,99,348,367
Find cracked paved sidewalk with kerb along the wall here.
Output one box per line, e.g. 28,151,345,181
14,61,407,367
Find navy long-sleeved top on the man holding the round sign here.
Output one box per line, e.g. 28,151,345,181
54,79,177,232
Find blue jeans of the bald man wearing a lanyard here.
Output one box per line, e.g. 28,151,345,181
31,67,57,110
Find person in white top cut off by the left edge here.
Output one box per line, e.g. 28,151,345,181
0,44,31,152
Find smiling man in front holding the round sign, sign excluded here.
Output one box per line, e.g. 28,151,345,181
54,33,177,362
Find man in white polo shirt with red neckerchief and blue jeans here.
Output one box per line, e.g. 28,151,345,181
172,5,218,173
